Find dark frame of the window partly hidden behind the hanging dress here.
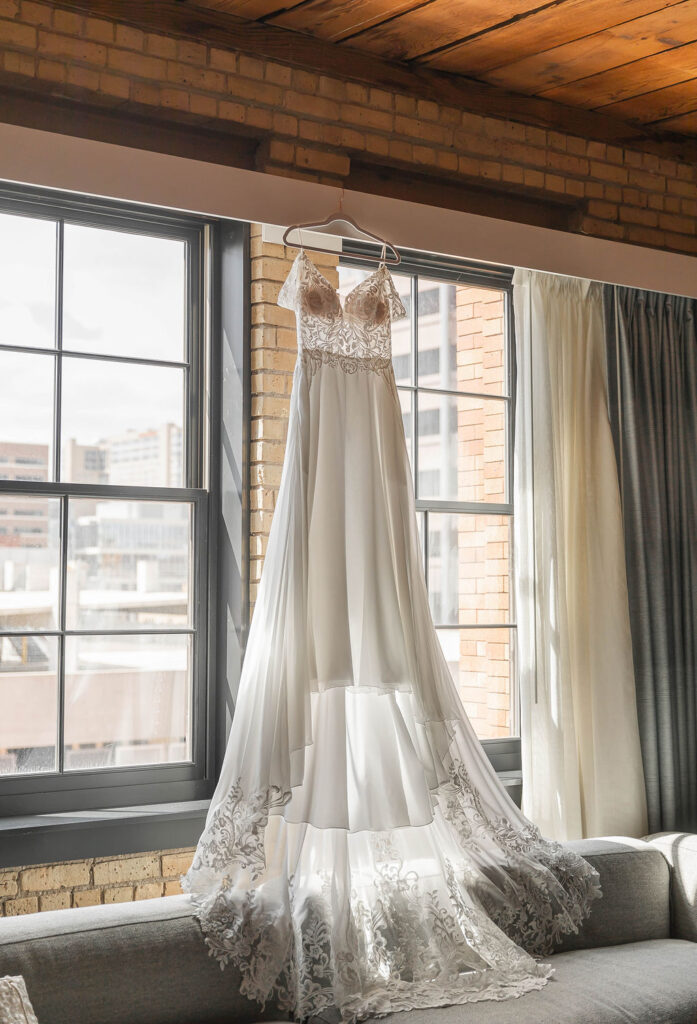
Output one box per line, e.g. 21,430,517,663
339,240,521,774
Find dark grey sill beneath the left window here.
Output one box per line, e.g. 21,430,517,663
0,800,209,868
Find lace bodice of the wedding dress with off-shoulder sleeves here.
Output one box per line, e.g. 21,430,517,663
278,249,406,365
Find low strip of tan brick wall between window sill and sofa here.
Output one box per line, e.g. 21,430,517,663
0,850,193,916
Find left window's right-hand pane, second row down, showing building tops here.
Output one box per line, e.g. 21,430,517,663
60,356,184,487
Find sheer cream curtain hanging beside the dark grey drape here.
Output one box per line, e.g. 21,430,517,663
514,270,646,840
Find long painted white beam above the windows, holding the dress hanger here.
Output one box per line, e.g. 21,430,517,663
0,124,697,297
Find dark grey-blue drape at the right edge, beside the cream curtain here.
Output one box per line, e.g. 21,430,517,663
605,286,697,831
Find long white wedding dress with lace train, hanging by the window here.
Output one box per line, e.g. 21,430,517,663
184,252,600,1021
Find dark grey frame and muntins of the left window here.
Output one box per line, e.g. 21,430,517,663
0,183,219,817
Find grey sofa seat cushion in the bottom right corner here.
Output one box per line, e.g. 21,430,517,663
380,939,697,1024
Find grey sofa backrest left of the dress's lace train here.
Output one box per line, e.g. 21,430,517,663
0,896,278,1024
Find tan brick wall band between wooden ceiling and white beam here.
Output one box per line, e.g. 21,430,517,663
0,0,697,253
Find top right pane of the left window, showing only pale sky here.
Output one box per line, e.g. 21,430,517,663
63,224,186,361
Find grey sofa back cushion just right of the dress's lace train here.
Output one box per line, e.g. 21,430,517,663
557,839,667,952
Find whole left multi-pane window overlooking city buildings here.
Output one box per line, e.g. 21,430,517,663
0,182,211,812
